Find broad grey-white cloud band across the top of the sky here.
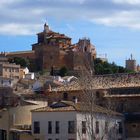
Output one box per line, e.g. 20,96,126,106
0,0,140,34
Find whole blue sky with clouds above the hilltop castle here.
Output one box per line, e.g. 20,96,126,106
0,0,140,65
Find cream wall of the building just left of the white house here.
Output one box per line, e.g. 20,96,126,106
0,102,47,140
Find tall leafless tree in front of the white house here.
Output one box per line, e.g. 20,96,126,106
78,57,123,140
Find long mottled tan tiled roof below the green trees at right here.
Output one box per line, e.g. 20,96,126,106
52,73,140,92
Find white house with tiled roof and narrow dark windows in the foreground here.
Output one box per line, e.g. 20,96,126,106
32,101,125,140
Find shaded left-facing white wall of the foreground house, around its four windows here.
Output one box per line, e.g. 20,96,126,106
32,112,76,140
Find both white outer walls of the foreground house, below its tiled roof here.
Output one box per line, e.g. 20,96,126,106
32,112,123,140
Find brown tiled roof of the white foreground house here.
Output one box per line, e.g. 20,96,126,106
32,101,122,116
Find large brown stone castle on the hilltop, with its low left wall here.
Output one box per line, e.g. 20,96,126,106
7,23,96,71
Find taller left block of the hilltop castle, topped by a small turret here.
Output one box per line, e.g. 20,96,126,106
32,23,71,71
